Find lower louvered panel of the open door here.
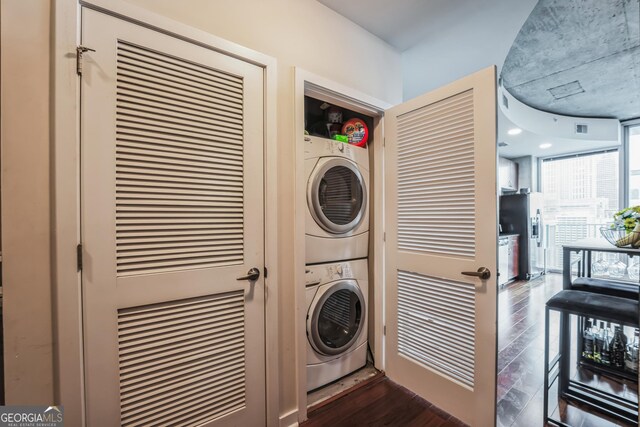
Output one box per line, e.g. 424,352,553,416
398,270,475,388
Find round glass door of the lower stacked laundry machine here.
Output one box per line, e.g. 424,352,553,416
307,280,366,355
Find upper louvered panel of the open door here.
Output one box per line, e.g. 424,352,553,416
397,91,475,258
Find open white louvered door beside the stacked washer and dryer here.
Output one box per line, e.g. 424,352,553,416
385,67,497,427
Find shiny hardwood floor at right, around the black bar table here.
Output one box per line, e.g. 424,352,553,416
497,274,637,427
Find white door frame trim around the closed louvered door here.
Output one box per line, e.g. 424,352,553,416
51,0,280,426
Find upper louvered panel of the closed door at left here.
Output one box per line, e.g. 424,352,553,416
116,41,244,277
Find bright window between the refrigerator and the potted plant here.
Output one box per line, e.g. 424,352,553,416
540,150,620,271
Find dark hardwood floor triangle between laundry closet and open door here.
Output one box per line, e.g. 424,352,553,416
301,376,464,427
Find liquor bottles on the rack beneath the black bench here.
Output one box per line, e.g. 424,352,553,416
582,319,640,373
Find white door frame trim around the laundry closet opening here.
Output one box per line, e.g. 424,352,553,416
294,67,391,425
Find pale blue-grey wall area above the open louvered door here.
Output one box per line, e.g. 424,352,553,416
402,0,537,100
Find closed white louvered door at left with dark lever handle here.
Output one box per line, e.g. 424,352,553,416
80,9,265,426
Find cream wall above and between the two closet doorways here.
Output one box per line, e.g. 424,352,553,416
110,0,402,422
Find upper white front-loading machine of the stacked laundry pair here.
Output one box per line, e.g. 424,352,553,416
304,136,369,264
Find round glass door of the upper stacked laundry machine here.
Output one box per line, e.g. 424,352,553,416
307,158,367,234
